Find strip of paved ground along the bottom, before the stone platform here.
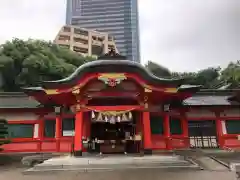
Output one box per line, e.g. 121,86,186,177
0,167,236,180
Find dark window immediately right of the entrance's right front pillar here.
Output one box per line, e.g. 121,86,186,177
150,115,163,135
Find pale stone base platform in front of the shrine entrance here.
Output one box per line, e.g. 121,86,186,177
25,155,199,174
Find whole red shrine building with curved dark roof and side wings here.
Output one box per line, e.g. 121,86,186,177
0,53,240,156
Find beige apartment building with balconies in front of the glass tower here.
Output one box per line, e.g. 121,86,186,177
54,26,118,56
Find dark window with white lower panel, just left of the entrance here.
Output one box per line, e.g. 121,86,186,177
62,117,75,136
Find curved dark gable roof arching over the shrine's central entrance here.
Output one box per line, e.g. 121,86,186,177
42,58,184,88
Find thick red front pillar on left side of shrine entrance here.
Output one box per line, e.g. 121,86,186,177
74,111,83,156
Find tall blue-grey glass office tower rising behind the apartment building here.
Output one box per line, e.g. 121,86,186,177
66,0,140,62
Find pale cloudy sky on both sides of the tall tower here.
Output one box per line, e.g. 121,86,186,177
0,0,240,71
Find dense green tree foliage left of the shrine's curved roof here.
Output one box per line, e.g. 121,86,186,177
0,39,95,91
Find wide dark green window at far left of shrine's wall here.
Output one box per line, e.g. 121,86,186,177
8,124,34,138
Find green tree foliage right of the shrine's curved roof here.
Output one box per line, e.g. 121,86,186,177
146,61,240,88
